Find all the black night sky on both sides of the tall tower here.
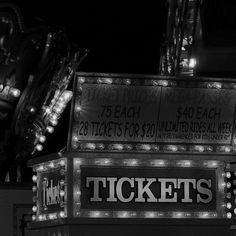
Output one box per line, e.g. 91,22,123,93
4,0,236,155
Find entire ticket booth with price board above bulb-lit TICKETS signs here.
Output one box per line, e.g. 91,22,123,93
29,73,236,236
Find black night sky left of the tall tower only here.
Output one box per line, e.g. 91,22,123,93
8,0,167,156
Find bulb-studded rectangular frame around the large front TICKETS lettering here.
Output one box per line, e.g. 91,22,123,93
72,157,227,219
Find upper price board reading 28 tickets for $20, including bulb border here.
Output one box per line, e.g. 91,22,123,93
69,74,236,152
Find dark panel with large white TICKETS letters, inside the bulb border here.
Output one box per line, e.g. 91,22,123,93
81,166,217,211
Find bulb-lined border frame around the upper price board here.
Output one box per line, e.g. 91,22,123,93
67,72,236,154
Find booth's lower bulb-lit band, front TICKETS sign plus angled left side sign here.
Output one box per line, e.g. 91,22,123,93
30,154,233,221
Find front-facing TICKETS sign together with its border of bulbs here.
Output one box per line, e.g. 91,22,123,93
73,158,226,218
